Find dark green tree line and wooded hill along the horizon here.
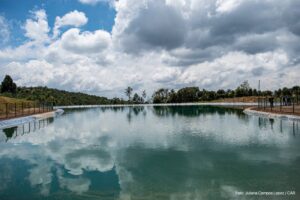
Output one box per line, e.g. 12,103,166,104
1,75,300,105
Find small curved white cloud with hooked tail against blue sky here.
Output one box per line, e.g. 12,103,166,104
53,10,88,37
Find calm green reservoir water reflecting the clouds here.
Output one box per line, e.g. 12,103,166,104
0,106,300,200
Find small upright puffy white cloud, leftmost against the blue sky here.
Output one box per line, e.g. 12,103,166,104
24,10,50,43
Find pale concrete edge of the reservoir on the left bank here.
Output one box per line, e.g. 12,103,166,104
0,109,64,129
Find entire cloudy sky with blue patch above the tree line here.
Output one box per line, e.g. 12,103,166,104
0,0,300,97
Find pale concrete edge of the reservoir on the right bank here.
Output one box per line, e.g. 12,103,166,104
243,108,300,121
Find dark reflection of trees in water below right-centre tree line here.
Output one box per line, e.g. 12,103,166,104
153,106,248,119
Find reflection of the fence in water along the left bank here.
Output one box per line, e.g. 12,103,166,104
2,117,54,142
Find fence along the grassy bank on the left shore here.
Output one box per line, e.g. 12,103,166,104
0,102,53,119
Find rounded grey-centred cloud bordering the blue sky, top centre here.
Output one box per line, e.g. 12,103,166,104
116,0,185,53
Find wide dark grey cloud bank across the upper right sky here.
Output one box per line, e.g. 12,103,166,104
114,0,297,66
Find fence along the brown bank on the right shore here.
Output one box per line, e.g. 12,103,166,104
257,96,300,114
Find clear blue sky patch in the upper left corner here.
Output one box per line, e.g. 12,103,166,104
0,0,116,46
